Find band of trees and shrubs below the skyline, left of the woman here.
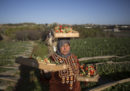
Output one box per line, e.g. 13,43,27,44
0,23,46,40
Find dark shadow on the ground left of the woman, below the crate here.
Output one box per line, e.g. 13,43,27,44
14,58,49,91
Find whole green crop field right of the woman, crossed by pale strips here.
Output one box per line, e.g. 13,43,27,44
71,38,130,91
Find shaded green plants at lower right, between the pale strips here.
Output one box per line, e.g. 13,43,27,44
81,63,130,91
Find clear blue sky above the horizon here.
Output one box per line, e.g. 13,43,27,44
0,0,130,24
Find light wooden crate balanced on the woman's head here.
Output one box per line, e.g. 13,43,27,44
54,30,79,38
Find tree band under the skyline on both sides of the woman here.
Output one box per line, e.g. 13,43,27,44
0,23,129,41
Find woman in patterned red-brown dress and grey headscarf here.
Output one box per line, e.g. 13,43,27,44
41,38,81,91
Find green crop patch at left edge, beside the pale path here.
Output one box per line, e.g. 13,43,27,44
0,41,30,65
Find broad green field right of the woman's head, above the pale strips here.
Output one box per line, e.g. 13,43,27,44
71,38,130,58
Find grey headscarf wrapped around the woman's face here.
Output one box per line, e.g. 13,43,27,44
56,38,71,58
